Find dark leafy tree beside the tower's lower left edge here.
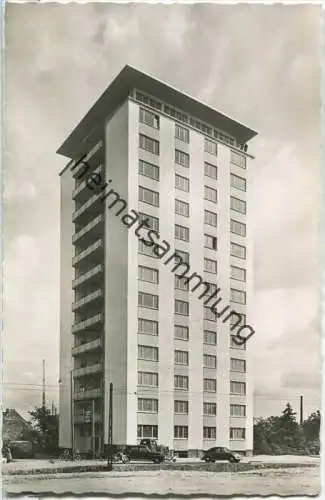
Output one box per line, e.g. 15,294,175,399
29,406,59,453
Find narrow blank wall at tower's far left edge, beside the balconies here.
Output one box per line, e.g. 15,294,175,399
59,168,74,448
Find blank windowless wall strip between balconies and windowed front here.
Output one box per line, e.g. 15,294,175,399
104,103,128,444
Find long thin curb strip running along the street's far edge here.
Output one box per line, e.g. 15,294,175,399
2,462,319,476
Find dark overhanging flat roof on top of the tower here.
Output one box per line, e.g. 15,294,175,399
57,65,257,158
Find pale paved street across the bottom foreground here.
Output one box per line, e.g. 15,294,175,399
3,467,320,496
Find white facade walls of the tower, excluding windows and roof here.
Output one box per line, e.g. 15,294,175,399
60,68,253,455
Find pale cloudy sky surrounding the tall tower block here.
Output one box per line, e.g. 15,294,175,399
3,4,320,415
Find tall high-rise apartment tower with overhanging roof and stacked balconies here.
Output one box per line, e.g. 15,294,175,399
58,66,256,456
